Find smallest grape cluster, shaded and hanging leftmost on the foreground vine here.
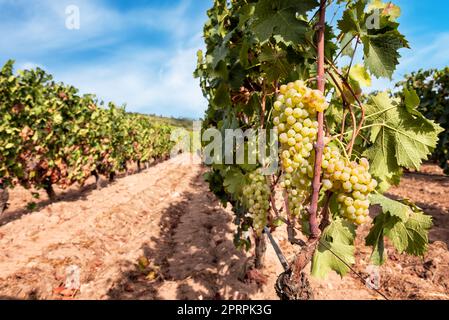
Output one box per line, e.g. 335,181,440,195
243,169,271,235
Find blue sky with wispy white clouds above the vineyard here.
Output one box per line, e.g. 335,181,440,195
0,0,449,118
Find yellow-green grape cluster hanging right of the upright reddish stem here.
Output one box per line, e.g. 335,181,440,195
322,146,377,225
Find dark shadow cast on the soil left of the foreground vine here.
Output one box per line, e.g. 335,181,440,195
103,175,257,300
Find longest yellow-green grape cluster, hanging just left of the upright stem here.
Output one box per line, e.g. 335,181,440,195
273,80,328,215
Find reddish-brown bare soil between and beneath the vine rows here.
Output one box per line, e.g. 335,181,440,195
0,155,449,299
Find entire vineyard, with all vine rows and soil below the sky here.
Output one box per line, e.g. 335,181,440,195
0,0,449,300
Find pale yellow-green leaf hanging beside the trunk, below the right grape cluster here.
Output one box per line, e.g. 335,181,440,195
312,217,355,279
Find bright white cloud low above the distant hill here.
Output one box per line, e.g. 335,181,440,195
52,36,206,117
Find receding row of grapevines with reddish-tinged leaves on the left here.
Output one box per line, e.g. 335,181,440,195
0,61,178,211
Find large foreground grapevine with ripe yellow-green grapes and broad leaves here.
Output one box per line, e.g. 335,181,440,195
195,0,442,298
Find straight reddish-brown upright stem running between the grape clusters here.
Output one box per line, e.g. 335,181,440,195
309,0,326,239
